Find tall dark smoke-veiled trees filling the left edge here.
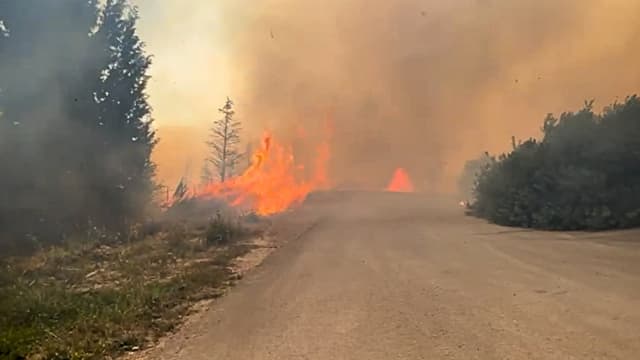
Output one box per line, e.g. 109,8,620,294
0,0,156,247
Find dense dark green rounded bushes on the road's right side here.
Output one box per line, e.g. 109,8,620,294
471,96,640,230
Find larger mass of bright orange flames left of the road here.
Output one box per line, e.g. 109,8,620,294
199,134,330,215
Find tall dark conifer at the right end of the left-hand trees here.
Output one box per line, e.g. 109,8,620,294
90,0,156,225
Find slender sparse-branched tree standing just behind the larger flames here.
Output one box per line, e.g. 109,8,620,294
202,98,242,182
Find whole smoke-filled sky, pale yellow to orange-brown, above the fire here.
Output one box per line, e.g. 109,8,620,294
138,0,640,191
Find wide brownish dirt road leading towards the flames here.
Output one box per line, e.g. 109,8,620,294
151,194,640,360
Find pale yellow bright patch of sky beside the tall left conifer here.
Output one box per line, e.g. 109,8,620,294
133,0,233,187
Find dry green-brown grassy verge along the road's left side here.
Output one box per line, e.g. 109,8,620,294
0,219,262,359
